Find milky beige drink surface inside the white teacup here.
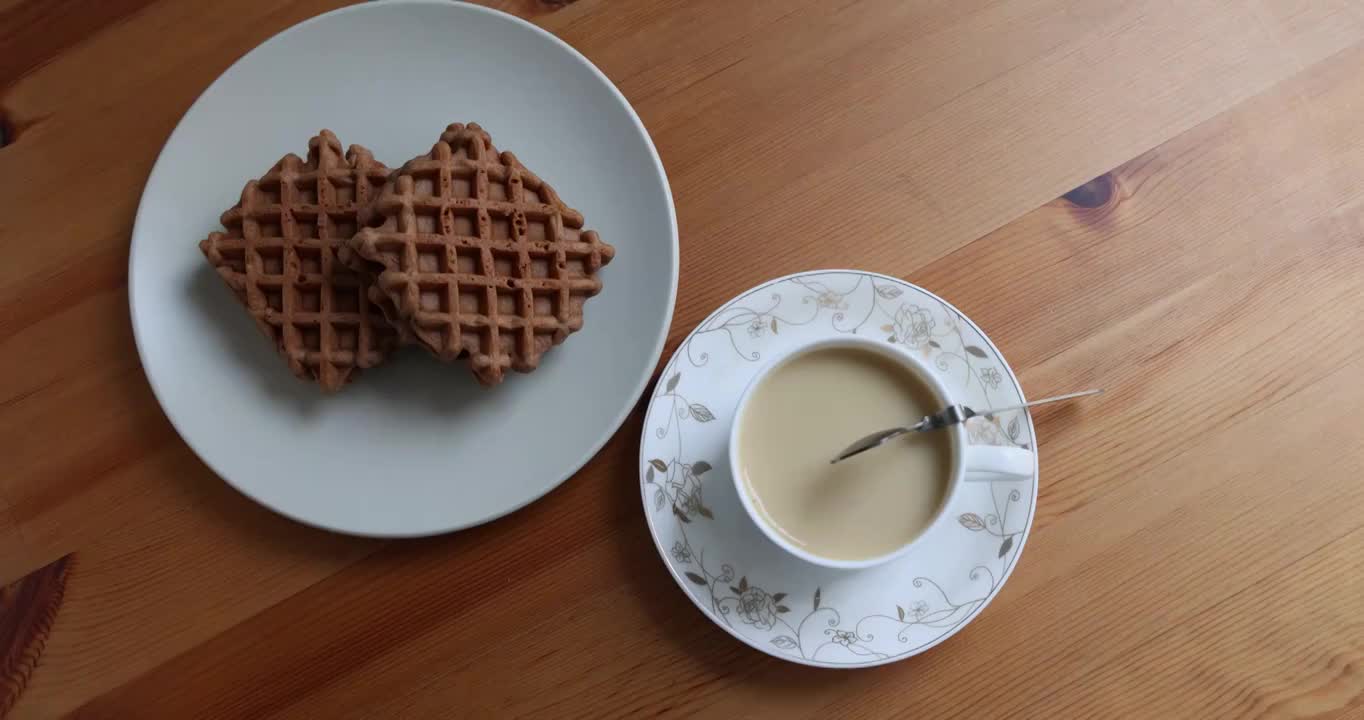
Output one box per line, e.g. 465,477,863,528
737,348,953,560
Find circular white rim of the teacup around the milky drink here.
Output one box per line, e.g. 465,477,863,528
728,335,967,570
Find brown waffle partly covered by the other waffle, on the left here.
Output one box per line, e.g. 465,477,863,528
199,130,398,391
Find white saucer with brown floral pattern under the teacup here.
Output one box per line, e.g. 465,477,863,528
640,270,1037,668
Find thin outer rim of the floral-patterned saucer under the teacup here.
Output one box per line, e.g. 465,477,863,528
636,267,1042,670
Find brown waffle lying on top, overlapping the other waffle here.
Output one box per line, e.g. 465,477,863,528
351,123,615,385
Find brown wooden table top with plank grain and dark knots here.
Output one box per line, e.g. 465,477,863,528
0,0,1364,719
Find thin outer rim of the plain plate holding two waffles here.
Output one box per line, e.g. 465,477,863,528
128,0,681,539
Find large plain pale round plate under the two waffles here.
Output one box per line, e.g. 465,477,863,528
128,1,678,536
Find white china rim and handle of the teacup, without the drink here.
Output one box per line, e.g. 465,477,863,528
730,335,1035,570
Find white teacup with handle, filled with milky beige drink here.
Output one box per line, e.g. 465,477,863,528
730,335,1035,569
